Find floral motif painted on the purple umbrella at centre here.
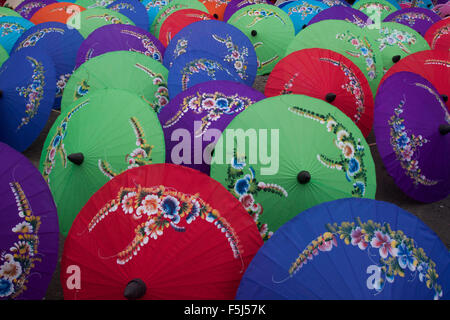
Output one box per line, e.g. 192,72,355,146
163,92,255,137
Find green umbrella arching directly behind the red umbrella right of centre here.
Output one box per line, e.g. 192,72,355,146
286,20,383,96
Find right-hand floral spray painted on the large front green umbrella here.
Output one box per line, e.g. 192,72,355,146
289,107,367,198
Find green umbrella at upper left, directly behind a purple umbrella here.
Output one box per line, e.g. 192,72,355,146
78,8,135,38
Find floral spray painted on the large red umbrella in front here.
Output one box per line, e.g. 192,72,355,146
88,186,244,268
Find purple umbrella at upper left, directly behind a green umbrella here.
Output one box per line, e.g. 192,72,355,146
75,24,165,68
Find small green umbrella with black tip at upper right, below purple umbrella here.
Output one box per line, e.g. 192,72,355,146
366,22,431,73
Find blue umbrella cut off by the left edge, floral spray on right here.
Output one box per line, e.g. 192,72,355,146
0,48,56,152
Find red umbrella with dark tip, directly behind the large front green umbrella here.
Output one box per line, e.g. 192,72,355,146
264,49,374,137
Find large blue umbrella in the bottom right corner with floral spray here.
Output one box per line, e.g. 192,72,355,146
236,198,450,300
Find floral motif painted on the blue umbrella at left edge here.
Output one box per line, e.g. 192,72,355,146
16,57,45,131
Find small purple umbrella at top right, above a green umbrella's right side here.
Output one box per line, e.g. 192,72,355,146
384,8,441,36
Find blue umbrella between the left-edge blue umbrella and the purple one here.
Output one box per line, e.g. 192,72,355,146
11,22,84,109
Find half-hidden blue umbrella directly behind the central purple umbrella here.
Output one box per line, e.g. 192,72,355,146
167,51,244,99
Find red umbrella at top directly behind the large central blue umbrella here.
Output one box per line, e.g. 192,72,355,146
159,9,213,47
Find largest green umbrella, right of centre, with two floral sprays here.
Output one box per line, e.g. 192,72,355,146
211,95,376,239
